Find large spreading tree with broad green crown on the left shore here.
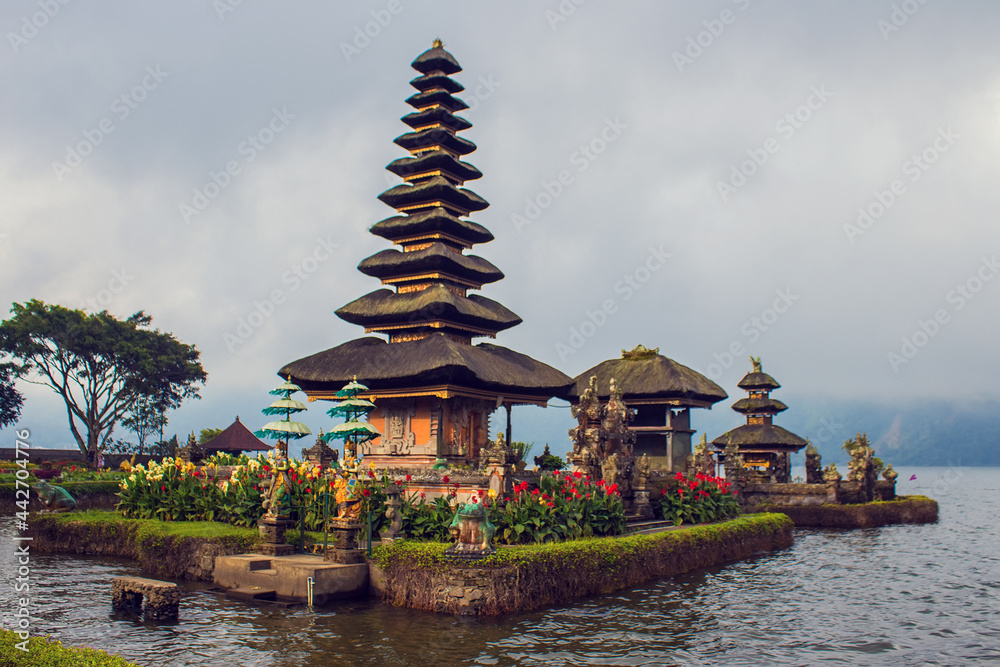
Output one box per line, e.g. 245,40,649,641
0,299,207,463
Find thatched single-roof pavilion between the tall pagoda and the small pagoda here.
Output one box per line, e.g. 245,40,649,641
564,345,727,472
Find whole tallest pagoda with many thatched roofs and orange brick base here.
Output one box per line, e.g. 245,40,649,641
279,41,572,465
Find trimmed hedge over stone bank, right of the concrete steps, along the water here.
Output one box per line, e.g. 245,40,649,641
372,514,793,615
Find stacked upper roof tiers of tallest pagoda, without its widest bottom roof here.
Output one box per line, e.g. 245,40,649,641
337,42,521,342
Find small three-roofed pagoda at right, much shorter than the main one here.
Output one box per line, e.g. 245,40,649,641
712,357,809,483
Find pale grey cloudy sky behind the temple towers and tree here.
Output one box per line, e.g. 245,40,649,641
0,0,1000,454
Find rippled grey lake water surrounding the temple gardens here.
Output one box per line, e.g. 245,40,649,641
0,468,1000,667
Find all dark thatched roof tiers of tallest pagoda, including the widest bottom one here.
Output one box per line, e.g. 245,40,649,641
279,42,572,402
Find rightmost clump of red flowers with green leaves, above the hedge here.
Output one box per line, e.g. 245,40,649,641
653,472,740,526
